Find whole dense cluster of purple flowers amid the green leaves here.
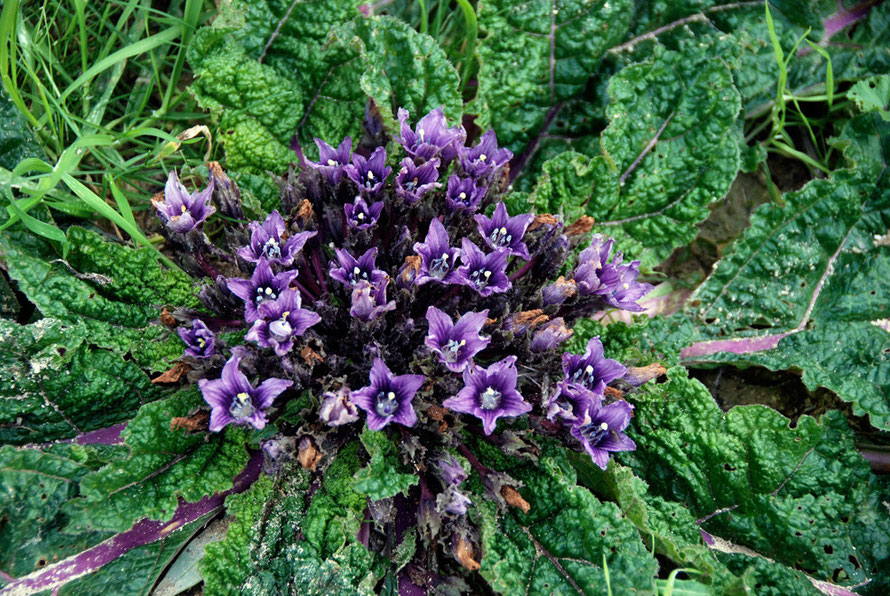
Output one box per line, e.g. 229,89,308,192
155,109,651,544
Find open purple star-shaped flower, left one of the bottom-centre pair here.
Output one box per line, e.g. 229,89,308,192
352,358,426,430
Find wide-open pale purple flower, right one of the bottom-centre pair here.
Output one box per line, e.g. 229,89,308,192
442,356,532,435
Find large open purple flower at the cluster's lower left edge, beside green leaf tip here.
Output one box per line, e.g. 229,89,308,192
198,355,293,432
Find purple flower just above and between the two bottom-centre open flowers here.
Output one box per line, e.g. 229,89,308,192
426,306,491,372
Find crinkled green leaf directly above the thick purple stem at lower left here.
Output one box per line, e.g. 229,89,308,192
68,387,247,532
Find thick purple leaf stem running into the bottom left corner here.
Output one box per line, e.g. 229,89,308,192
0,451,263,596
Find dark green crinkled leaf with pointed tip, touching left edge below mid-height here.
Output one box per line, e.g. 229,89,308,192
0,319,163,444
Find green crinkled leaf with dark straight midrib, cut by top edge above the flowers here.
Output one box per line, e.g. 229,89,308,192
467,0,634,152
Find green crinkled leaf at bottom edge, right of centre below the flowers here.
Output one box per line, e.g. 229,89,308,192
474,443,658,594
